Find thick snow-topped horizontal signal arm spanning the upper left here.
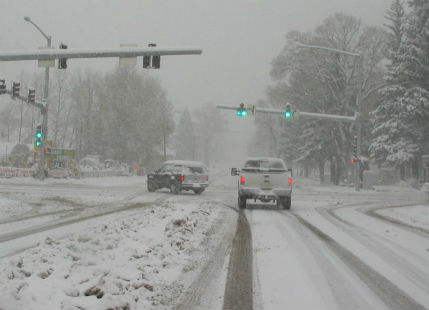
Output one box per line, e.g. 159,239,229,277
0,47,202,61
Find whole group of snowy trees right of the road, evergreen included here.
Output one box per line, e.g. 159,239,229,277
251,0,429,183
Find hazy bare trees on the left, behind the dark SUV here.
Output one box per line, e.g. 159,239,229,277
0,68,174,163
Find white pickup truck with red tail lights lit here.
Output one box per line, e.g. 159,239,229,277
231,157,293,209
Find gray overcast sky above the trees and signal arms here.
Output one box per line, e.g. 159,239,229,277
0,0,391,109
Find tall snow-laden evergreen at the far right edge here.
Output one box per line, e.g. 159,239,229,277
370,0,429,178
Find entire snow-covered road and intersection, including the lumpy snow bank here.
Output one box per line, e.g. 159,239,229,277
0,175,429,310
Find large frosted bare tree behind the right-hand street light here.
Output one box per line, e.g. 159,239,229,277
262,13,385,183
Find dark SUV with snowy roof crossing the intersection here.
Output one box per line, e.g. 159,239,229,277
147,160,209,194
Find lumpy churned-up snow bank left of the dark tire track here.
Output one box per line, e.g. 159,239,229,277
0,201,220,310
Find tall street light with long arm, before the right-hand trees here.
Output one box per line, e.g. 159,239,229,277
294,42,363,191
